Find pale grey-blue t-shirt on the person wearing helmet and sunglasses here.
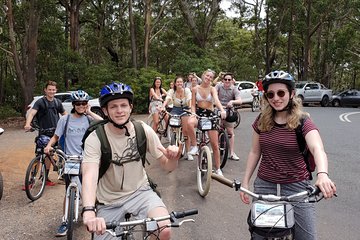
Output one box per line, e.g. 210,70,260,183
55,114,89,155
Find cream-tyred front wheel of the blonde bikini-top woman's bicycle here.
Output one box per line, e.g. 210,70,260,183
196,146,212,197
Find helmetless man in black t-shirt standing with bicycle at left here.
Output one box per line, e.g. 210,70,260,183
23,81,66,190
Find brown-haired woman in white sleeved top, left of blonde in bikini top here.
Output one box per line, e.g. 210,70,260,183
163,76,194,158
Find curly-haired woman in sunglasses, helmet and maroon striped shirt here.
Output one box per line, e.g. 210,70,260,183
240,71,336,240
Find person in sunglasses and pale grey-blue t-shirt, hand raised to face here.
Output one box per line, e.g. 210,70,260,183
44,90,102,237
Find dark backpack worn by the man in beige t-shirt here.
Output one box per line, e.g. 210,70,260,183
82,119,160,197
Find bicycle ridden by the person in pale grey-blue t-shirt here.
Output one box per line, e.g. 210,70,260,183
60,155,82,240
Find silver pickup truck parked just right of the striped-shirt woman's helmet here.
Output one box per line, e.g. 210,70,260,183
295,82,332,107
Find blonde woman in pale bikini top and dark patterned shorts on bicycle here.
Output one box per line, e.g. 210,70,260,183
188,69,226,175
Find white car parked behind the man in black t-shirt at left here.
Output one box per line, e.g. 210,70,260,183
26,91,104,117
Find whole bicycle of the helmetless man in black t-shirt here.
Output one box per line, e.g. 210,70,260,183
25,128,66,201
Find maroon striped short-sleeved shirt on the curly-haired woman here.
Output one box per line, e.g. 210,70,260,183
252,118,318,184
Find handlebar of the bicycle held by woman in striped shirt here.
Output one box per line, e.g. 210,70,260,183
211,173,330,202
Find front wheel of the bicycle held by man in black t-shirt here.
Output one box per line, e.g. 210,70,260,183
25,155,46,201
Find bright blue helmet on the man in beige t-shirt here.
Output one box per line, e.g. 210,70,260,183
99,82,134,107
